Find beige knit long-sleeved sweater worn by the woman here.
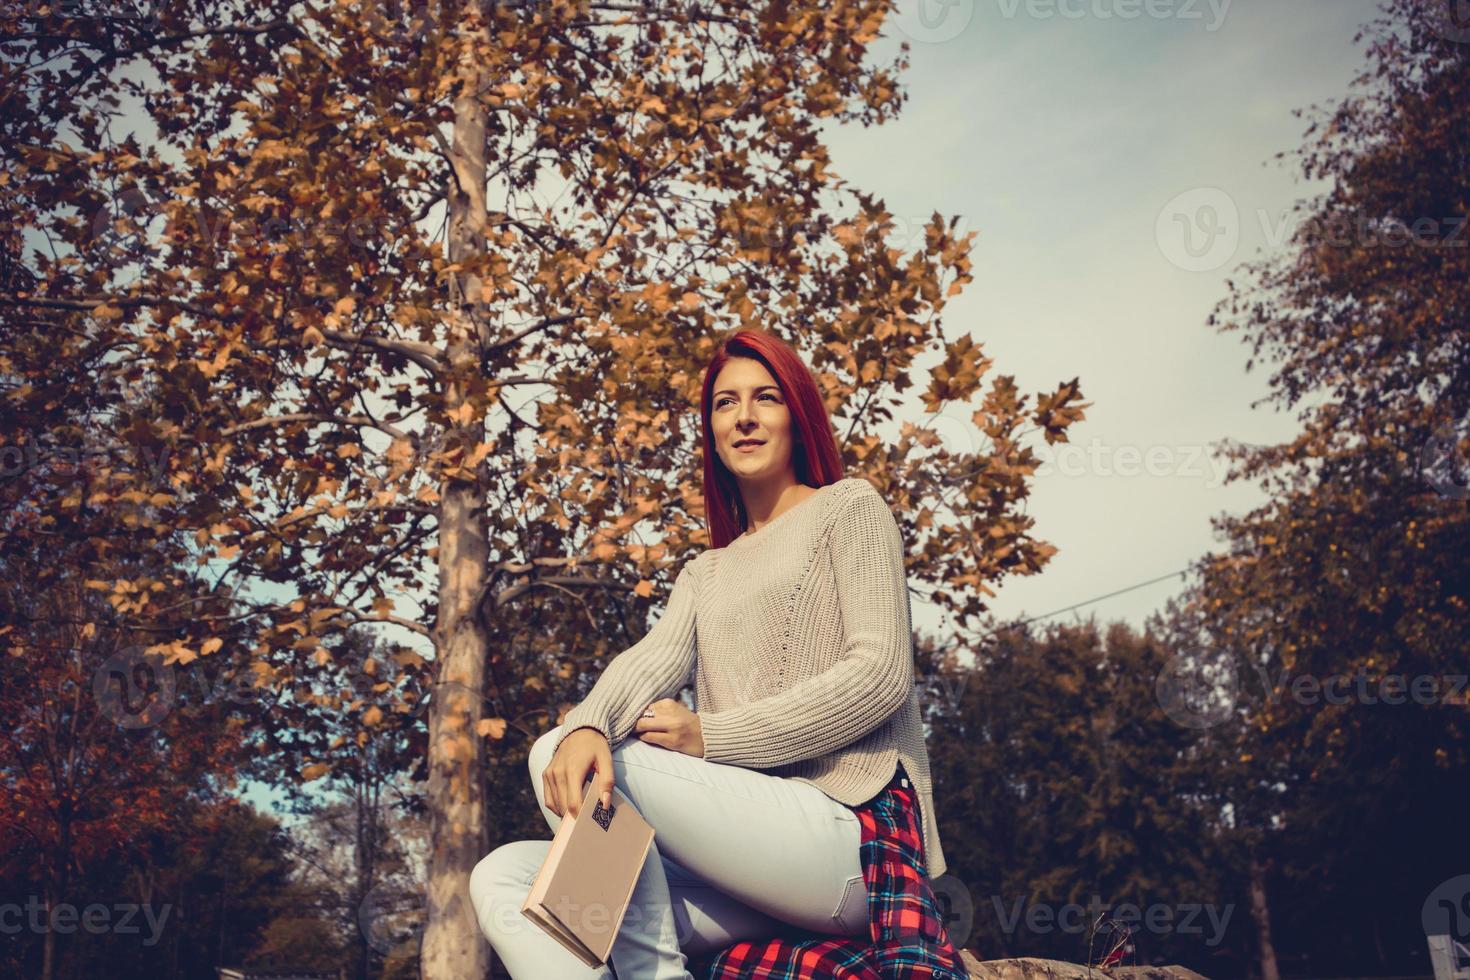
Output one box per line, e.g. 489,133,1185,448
557,476,945,877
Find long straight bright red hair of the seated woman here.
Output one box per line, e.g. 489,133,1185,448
700,329,844,548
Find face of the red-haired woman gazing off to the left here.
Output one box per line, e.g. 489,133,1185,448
710,357,795,483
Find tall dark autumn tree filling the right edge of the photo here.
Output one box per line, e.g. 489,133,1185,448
1188,0,1470,977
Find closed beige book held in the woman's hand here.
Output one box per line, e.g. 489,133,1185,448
520,779,653,968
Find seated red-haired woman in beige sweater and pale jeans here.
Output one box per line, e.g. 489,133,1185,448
470,331,953,980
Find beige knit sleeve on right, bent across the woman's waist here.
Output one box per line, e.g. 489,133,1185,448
700,480,913,768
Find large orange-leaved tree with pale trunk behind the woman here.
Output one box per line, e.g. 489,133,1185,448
0,0,1085,977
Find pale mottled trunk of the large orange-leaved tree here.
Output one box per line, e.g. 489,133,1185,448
419,9,490,980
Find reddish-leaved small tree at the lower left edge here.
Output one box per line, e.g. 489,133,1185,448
0,531,240,980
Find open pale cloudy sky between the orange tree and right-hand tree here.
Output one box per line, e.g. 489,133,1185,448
826,0,1399,652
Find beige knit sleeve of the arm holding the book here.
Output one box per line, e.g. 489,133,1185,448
553,560,698,752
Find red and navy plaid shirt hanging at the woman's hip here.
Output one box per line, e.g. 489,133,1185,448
689,767,969,980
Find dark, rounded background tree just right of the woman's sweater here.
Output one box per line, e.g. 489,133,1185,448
931,621,1220,976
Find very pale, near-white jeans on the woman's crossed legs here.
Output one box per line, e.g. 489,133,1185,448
469,727,869,980
